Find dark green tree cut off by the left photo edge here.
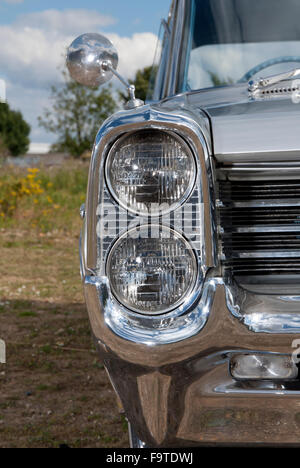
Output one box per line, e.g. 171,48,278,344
0,103,30,156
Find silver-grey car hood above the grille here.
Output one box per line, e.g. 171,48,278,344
163,85,300,162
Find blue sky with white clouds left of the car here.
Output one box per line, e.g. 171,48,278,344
0,0,171,143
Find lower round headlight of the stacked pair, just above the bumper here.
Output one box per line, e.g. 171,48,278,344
107,226,197,315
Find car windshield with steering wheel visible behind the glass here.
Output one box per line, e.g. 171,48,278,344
184,0,300,90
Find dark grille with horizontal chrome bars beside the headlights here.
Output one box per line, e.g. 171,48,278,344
218,164,300,282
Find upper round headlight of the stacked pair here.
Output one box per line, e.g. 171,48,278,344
106,130,196,216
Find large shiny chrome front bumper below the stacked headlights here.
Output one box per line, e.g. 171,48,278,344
84,277,300,447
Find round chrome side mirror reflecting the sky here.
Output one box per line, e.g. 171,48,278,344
66,33,119,87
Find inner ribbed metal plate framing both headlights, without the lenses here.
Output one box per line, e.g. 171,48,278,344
97,125,212,319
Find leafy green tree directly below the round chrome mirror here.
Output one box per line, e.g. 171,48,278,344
39,72,117,157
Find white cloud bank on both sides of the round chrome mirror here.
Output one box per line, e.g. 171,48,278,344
0,9,157,141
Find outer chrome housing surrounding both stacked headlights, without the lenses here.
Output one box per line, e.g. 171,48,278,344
82,105,217,344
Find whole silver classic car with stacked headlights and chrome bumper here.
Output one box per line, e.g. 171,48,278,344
69,0,300,447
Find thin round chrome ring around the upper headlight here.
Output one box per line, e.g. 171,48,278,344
105,128,197,217
